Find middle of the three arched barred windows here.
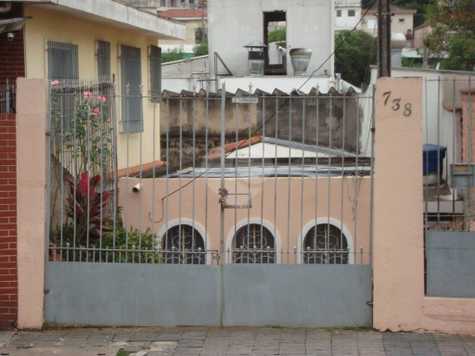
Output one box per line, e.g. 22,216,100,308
231,224,276,263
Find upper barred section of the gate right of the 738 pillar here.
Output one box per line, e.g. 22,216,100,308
423,75,475,231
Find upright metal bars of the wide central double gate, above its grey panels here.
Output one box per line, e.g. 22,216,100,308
49,82,373,265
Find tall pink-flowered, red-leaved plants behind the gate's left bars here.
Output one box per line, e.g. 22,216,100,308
50,81,115,250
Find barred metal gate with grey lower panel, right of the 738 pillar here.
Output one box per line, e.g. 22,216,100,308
423,73,475,298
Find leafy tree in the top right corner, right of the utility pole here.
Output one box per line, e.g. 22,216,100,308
425,0,475,70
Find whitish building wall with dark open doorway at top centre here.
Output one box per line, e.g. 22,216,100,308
208,0,335,76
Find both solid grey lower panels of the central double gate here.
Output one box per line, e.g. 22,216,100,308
46,262,371,327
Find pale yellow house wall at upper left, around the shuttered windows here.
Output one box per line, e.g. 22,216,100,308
25,6,160,169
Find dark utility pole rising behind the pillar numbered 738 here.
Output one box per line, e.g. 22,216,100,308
378,0,391,77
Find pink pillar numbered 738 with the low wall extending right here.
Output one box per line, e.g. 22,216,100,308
373,78,475,334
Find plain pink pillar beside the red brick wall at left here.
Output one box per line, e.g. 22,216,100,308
17,79,47,329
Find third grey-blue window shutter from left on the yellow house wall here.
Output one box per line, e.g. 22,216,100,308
120,46,143,133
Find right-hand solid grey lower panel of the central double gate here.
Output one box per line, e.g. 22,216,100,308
224,265,372,327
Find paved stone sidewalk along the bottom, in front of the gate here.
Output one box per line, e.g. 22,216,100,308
0,328,475,356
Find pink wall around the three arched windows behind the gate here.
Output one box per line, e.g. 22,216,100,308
119,177,370,263
